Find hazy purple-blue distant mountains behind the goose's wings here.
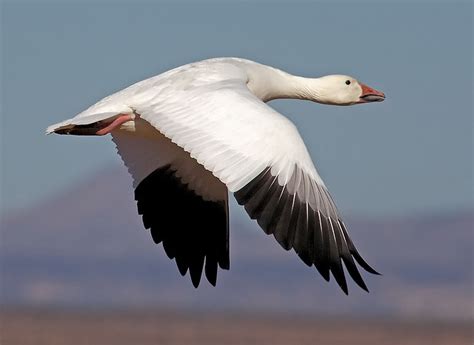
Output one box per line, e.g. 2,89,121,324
0,166,474,319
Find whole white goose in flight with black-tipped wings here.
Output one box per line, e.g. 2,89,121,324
47,58,385,294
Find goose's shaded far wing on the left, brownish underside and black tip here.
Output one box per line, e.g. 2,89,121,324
112,125,229,287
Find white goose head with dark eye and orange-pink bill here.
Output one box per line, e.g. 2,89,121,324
315,75,385,105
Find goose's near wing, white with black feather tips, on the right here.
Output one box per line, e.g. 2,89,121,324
130,67,377,293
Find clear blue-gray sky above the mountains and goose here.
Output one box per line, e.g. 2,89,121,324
1,1,473,216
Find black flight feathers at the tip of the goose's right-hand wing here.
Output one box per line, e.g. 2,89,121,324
234,166,378,294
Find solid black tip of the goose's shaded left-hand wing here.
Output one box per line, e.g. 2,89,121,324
135,165,230,288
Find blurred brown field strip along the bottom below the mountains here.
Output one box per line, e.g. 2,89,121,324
0,310,473,345
